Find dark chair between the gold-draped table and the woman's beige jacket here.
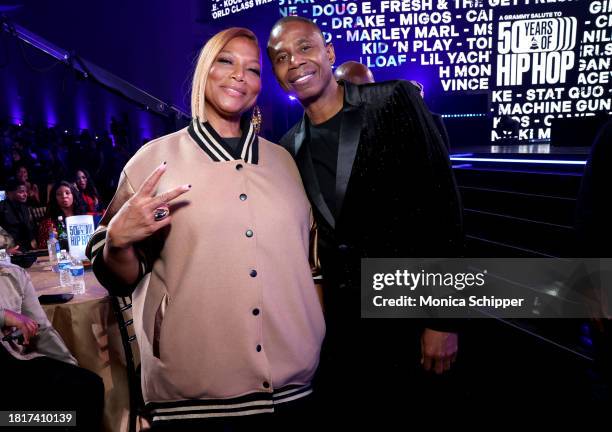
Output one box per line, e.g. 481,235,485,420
111,296,147,432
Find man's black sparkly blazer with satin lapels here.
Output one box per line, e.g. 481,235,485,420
281,81,463,333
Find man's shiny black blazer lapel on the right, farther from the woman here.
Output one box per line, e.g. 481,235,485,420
336,83,363,221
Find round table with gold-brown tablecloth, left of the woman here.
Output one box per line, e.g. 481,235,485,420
28,258,129,432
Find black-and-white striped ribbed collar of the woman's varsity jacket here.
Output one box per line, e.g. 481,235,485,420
187,116,259,165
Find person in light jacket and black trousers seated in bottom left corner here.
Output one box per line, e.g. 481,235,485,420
0,263,104,432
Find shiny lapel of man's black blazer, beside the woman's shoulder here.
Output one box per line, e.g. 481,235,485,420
293,115,336,228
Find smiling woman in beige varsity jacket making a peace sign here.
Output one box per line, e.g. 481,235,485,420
88,28,325,430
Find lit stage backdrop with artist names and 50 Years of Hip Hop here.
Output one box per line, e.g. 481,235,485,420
200,0,612,144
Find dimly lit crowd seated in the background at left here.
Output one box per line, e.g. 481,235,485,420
0,118,139,253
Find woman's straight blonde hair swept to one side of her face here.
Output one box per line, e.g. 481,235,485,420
191,27,259,121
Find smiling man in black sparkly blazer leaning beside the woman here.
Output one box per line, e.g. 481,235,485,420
267,17,463,418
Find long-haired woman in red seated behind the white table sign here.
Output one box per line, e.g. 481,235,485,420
38,181,86,248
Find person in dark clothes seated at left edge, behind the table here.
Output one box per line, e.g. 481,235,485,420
0,179,36,252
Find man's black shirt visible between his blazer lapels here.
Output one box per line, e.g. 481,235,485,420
309,110,343,216
